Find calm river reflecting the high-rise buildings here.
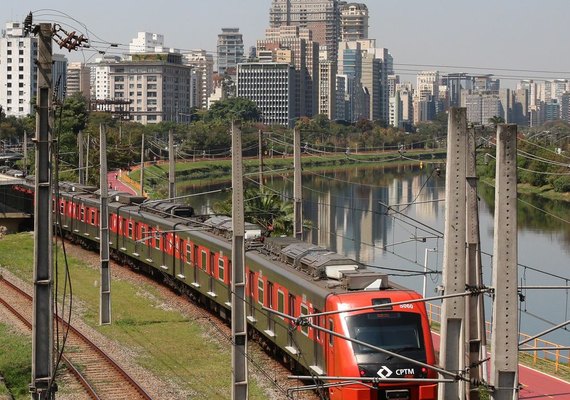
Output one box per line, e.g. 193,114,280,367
180,165,570,346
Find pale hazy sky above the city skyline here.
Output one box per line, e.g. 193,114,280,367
4,0,570,87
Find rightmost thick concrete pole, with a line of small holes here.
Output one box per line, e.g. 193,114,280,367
490,124,519,400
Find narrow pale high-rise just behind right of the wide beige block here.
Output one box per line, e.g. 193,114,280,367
182,50,214,109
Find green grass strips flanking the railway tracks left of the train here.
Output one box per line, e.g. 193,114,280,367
0,233,267,399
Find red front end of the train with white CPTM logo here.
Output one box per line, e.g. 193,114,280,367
327,289,437,400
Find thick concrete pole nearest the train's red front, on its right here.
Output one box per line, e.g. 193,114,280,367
438,108,467,400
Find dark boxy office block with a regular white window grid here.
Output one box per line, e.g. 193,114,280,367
236,62,297,127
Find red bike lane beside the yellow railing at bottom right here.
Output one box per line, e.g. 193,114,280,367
432,332,570,400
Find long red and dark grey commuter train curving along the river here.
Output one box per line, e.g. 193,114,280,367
18,184,437,400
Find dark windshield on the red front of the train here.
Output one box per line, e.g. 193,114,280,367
346,312,424,354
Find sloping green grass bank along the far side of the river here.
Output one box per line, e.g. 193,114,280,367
129,150,446,195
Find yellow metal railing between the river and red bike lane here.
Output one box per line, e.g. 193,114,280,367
426,303,570,373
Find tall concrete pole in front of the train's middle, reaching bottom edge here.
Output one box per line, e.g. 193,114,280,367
231,122,248,400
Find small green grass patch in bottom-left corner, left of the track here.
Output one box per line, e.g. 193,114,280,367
0,324,32,400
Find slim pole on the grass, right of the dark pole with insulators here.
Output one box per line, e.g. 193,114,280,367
99,125,111,325
